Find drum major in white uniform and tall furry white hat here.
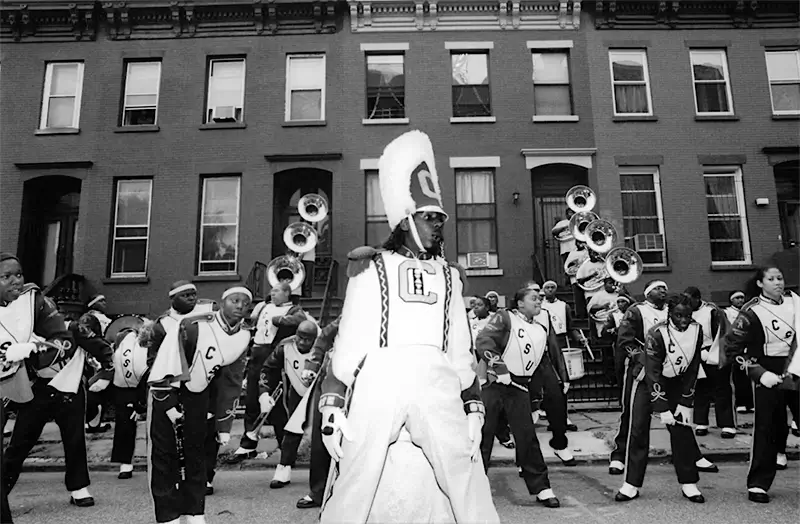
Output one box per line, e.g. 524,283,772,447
320,131,499,524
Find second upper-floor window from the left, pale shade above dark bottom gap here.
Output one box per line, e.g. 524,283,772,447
122,62,161,126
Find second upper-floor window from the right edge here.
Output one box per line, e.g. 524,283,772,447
689,49,733,115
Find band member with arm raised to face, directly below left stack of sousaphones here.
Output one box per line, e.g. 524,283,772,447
227,282,307,464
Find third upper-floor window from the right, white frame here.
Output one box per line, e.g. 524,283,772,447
608,49,653,116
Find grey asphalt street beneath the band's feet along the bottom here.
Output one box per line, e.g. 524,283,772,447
10,460,800,524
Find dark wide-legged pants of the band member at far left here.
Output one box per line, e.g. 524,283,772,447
2,379,89,493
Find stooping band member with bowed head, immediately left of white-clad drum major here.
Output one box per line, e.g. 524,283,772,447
258,320,318,489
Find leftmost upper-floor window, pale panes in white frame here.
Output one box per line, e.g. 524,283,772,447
39,62,83,129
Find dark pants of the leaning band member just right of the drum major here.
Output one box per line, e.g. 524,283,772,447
481,382,550,495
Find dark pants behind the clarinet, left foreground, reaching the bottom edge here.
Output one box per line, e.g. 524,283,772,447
147,386,208,522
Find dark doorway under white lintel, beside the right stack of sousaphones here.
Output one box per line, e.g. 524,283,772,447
531,164,589,282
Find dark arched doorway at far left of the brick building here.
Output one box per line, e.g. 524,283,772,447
19,176,81,288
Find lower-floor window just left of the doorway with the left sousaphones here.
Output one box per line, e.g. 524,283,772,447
200,177,239,274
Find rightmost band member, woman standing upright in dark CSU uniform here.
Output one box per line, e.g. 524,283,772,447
725,266,800,503
